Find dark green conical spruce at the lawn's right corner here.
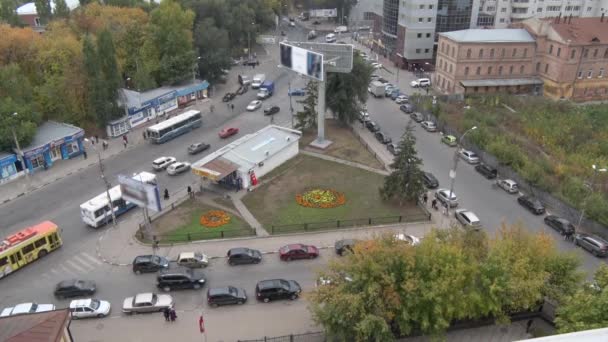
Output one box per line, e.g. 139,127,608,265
380,120,425,205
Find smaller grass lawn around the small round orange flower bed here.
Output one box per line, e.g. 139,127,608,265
152,199,251,243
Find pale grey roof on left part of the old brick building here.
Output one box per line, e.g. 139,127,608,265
439,29,534,43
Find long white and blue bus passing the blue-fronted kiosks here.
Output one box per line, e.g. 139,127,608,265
146,110,203,144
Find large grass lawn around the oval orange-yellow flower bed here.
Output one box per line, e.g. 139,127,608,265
243,155,424,231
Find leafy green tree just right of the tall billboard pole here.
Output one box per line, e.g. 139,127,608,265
325,53,373,124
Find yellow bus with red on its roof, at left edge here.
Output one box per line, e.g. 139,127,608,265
0,221,62,278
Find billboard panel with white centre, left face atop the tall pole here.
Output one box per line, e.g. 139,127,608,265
280,42,323,81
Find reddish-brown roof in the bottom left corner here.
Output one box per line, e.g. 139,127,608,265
0,309,70,342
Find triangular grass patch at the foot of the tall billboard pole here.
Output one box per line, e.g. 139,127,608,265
300,120,384,169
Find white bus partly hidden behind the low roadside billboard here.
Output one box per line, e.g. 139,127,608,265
80,171,156,228
